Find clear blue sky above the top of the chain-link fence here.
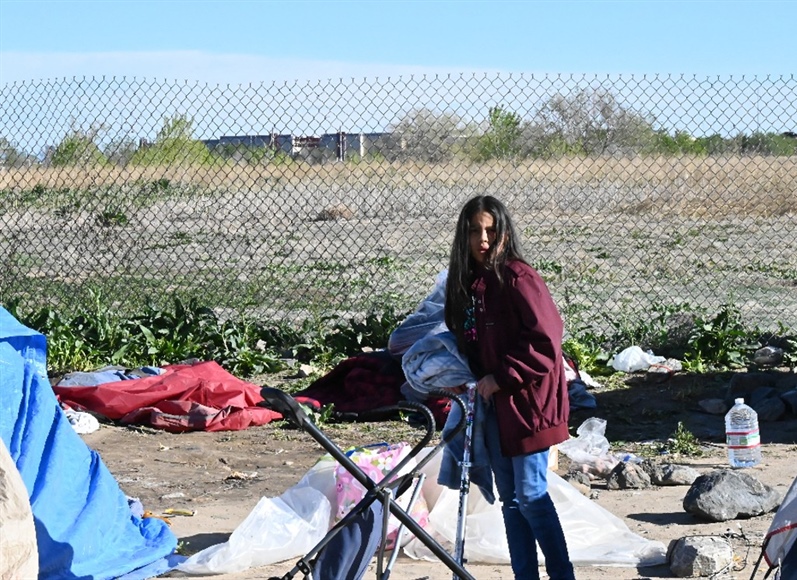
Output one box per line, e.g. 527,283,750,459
0,0,797,85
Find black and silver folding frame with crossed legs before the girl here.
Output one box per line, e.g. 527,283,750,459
260,386,475,580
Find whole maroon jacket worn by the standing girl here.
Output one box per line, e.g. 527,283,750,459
469,261,570,457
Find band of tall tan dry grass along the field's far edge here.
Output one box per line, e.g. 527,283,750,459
0,156,797,218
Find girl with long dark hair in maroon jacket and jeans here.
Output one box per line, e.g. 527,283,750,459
445,196,575,580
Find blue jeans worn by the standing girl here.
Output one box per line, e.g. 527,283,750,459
484,405,575,580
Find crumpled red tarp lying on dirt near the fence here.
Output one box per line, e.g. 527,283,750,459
53,361,282,433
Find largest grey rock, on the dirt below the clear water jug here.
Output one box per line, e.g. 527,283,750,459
683,469,781,522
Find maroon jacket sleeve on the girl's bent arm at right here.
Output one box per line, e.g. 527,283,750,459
494,264,564,391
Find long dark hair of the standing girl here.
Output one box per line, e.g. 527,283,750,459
445,195,525,343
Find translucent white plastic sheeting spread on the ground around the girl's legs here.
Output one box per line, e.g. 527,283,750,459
178,446,666,574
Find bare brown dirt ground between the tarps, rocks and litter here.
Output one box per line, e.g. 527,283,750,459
83,370,797,580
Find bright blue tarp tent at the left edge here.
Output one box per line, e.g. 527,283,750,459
0,307,177,579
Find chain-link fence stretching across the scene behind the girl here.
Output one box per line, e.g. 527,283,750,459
0,74,797,328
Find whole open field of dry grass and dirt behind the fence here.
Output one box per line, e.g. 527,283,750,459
0,156,797,327
